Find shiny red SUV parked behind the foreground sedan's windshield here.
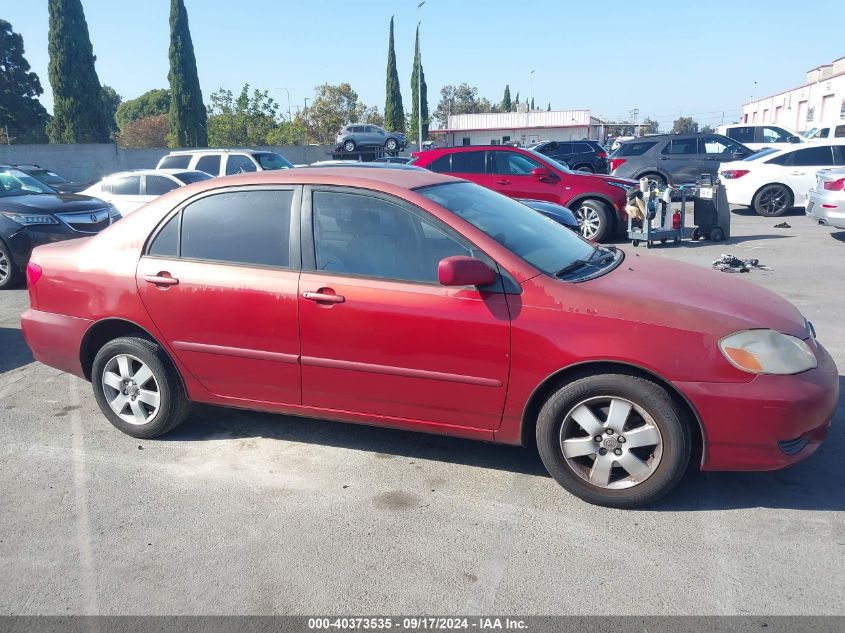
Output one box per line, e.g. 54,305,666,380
413,145,637,242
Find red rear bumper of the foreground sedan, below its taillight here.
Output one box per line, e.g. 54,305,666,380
21,309,93,378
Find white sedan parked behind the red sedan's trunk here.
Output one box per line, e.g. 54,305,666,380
81,169,212,216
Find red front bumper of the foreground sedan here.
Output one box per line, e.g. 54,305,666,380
675,343,839,470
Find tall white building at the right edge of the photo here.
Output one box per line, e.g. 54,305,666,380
741,57,845,132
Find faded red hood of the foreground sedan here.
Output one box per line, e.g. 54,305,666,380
561,254,809,338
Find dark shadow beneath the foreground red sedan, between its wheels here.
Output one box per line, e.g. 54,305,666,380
166,405,549,477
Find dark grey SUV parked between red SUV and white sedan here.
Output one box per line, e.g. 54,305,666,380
610,134,754,186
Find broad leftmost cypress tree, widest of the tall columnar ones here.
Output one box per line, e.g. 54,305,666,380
47,0,109,143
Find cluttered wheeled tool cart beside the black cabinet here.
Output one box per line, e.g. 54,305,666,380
625,178,687,248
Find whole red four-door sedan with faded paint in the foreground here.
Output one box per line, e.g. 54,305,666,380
22,167,838,507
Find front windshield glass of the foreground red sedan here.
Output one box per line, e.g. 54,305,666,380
417,182,596,275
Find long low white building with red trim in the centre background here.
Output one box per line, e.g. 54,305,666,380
431,110,604,147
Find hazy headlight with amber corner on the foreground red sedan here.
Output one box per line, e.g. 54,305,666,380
719,330,818,375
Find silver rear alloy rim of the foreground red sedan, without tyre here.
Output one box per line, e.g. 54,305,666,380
102,354,161,425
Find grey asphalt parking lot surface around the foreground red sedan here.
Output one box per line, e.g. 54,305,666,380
0,206,845,615
